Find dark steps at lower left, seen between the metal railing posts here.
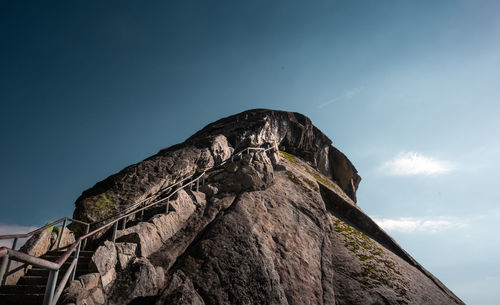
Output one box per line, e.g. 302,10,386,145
0,250,94,305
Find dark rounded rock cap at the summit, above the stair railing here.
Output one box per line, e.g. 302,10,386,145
74,109,361,222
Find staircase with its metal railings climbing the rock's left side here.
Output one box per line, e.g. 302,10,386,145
0,146,277,305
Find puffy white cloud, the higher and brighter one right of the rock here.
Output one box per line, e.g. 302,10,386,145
381,152,451,176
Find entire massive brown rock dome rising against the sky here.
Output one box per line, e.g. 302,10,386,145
9,109,463,305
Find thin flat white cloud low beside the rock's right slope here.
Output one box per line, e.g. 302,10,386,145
373,217,465,233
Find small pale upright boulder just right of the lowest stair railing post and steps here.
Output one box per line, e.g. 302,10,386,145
91,241,118,288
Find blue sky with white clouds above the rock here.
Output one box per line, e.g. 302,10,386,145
0,0,500,304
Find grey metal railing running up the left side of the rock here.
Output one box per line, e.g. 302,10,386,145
0,145,277,305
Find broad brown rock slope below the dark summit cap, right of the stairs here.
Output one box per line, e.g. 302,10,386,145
156,149,462,304
